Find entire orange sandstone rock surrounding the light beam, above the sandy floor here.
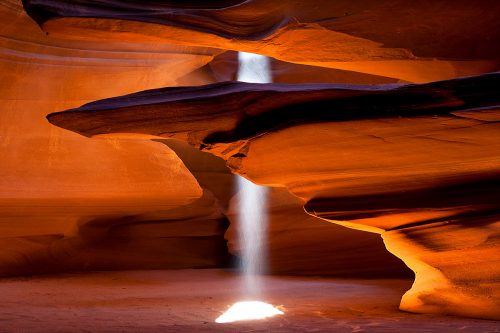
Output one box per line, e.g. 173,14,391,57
0,0,500,319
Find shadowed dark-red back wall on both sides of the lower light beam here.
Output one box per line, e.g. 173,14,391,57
163,140,413,278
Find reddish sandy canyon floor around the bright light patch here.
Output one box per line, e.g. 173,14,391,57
0,270,500,333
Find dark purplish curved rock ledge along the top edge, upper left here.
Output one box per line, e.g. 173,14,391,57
23,0,288,40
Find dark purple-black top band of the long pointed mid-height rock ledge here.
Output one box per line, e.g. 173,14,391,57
47,73,500,145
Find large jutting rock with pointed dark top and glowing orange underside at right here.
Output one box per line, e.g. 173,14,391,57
48,73,500,319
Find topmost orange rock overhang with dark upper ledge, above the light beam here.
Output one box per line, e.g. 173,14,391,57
24,0,500,82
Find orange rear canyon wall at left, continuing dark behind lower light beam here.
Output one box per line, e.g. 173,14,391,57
0,0,407,277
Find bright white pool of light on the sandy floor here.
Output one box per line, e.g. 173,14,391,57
215,301,283,324
